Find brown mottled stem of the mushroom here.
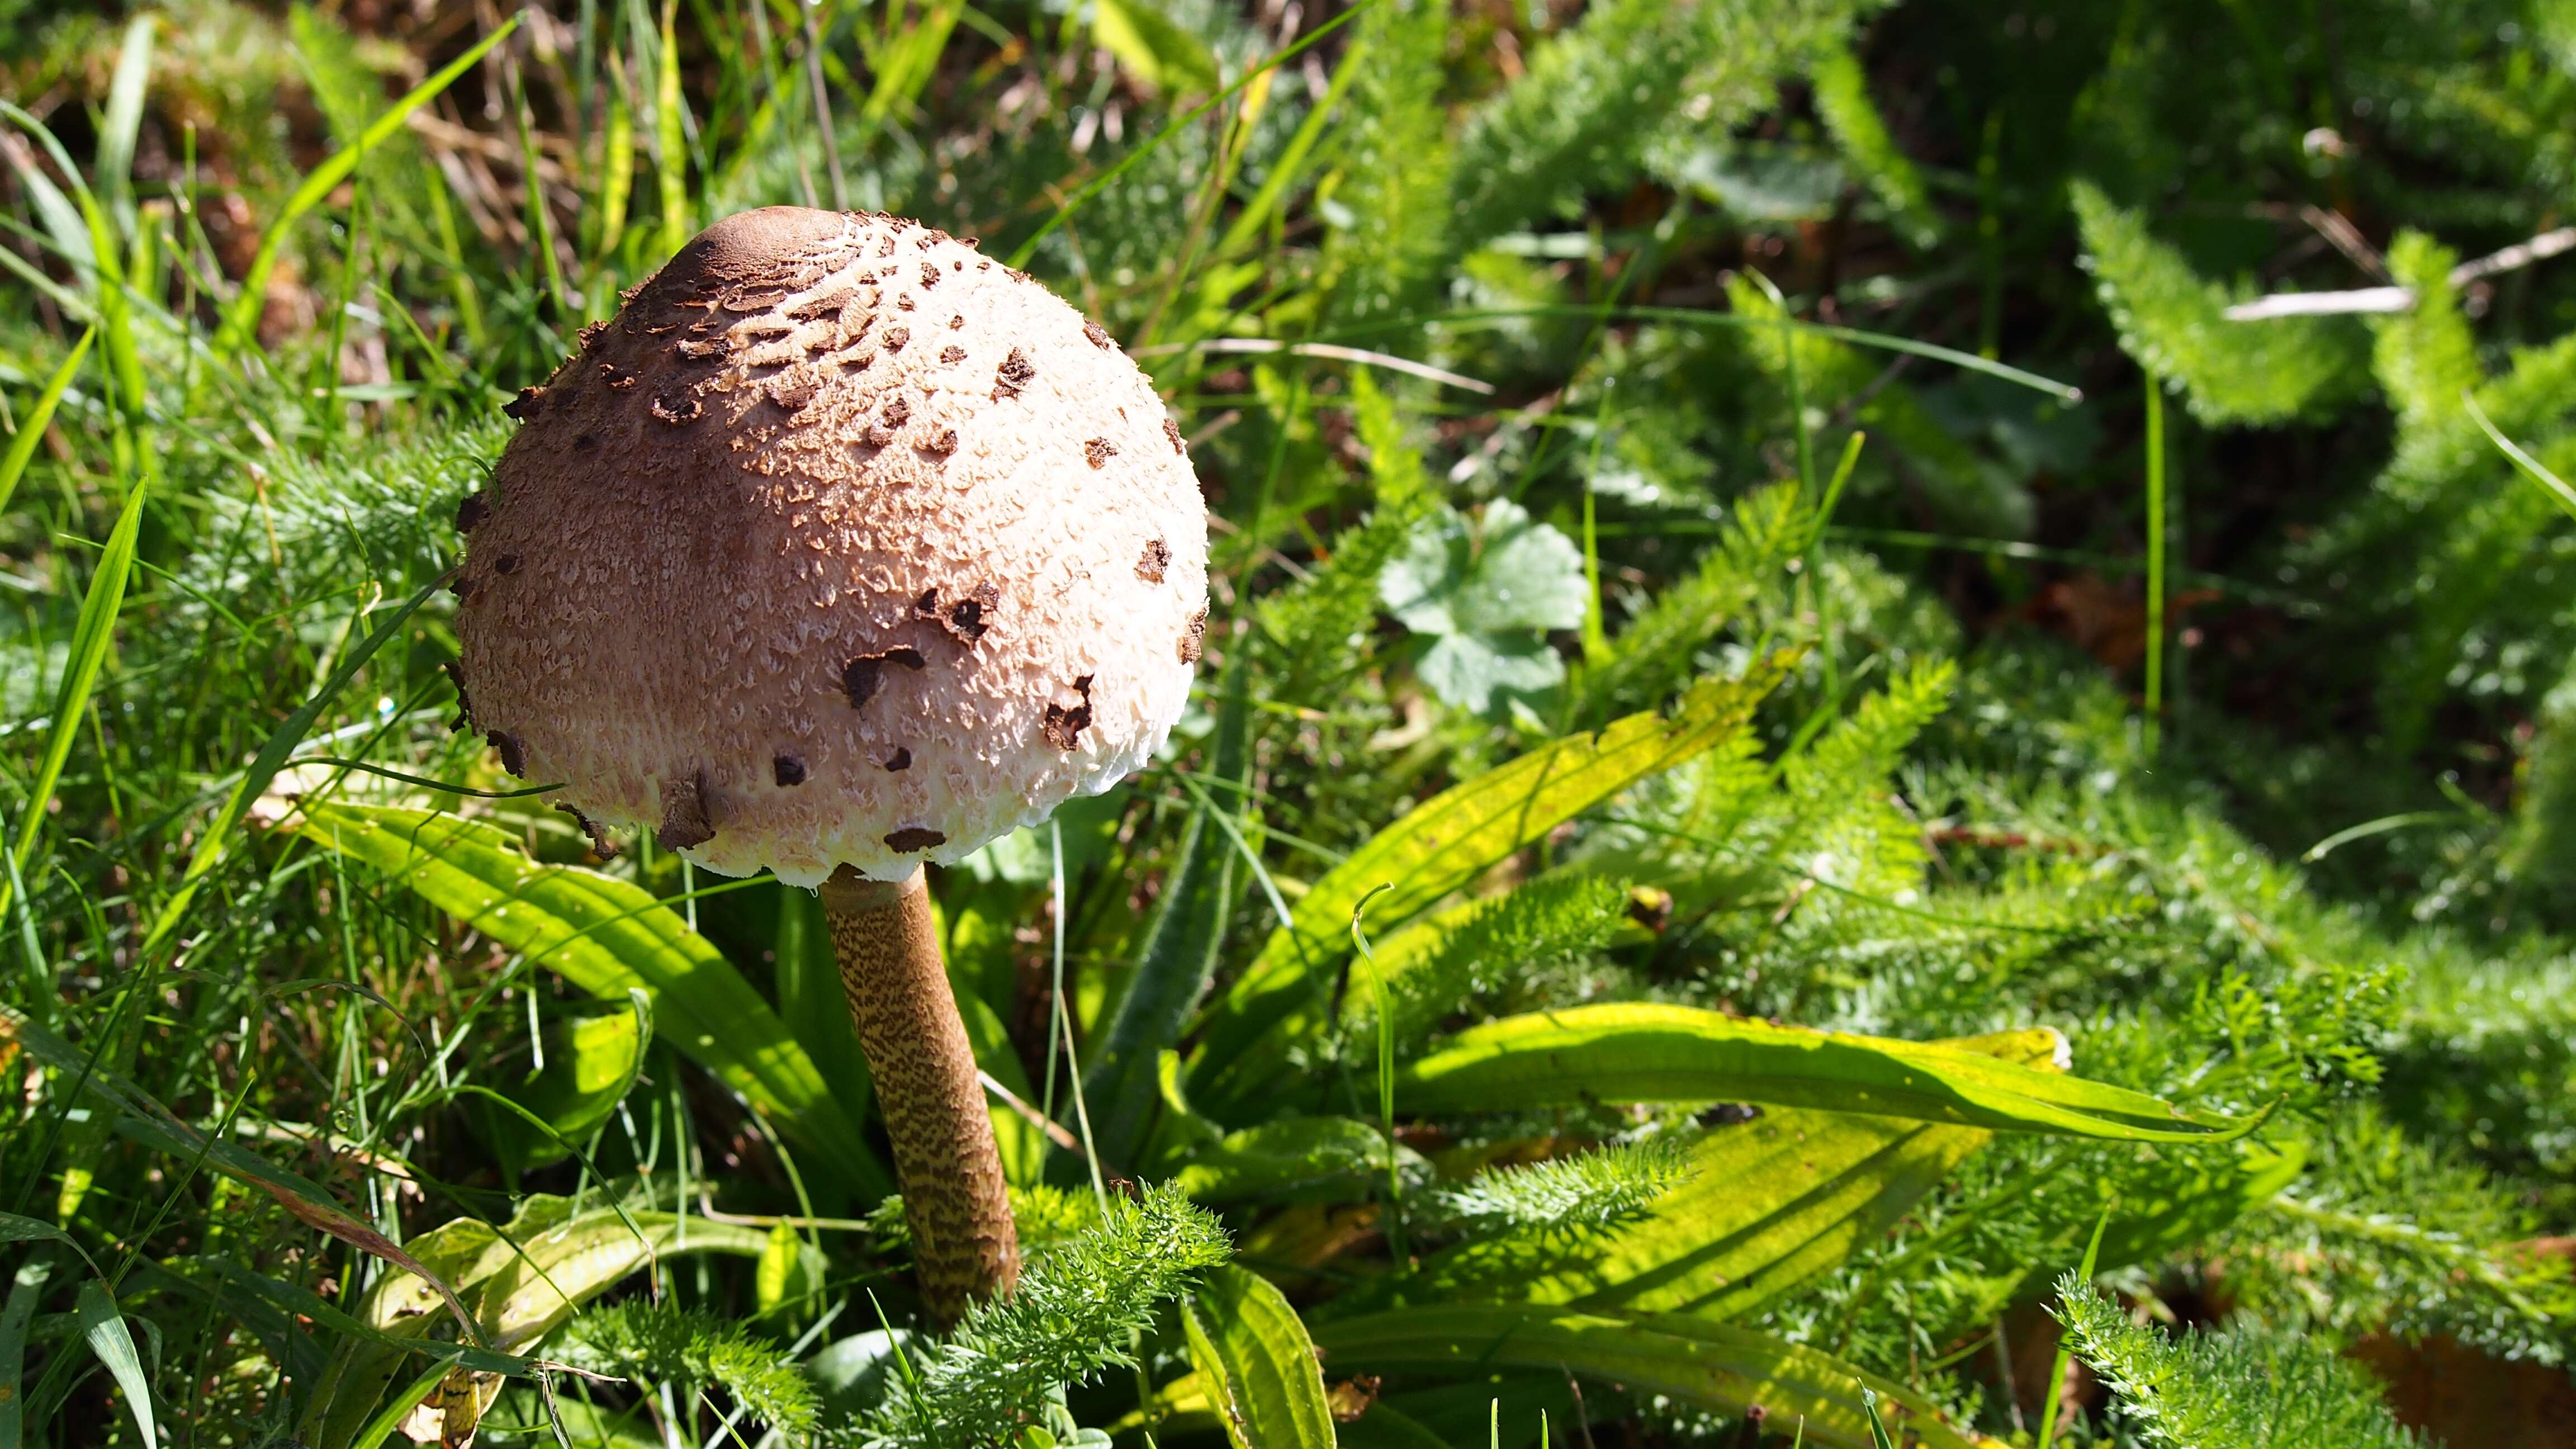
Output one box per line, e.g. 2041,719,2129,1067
822,866,1020,1325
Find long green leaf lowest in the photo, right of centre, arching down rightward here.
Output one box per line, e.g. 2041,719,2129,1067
1314,1305,1991,1449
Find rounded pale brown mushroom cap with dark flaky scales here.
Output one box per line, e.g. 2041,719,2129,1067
456,206,1208,887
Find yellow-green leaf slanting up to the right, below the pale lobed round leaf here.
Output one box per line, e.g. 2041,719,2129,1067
1190,657,1785,1116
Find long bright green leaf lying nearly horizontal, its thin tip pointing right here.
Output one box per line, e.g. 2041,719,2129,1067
1396,1003,2257,1142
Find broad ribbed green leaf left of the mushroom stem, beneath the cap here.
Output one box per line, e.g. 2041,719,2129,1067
286,802,891,1196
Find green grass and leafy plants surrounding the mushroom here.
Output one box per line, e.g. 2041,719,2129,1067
0,0,2576,1449
